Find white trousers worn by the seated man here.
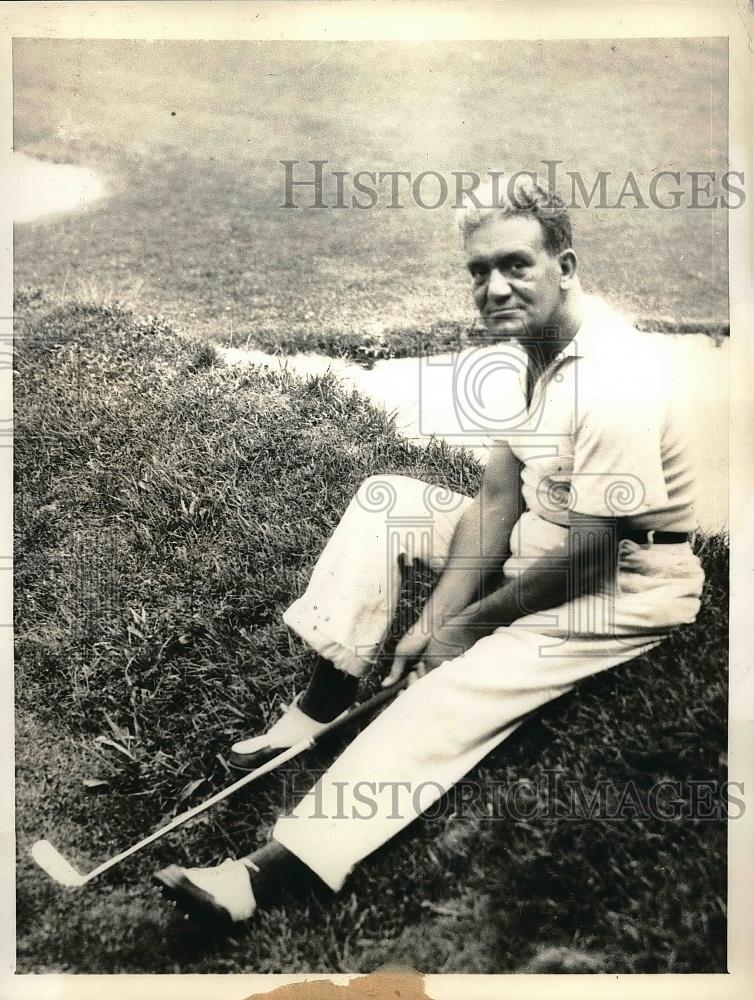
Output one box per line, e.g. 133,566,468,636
273,476,704,890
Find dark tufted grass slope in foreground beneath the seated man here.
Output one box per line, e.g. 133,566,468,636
16,298,727,972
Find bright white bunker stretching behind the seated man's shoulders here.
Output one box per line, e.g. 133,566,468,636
223,334,730,531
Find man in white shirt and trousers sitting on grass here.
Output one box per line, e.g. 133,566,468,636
156,178,703,922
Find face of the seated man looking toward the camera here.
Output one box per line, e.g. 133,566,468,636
466,215,563,340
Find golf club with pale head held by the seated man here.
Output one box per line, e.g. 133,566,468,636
31,673,412,889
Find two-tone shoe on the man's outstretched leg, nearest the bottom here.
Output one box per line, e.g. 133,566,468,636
154,858,257,929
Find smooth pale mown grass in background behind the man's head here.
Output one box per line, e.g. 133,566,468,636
14,39,727,350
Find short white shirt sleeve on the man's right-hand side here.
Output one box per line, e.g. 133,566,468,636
570,365,668,518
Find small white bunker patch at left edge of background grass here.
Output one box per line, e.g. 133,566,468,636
10,152,106,223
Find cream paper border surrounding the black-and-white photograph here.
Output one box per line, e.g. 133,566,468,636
0,0,754,1000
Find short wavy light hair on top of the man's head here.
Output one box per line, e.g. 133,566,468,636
458,174,573,256
